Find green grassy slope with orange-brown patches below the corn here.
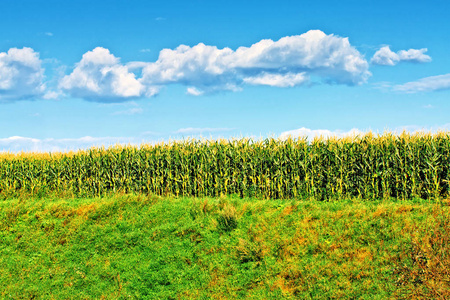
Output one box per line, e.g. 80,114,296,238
0,195,450,299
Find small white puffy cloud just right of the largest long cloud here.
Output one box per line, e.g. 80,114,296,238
370,46,431,66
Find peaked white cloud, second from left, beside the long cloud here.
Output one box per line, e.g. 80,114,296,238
59,47,157,102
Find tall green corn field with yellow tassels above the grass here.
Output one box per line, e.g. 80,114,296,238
0,132,450,200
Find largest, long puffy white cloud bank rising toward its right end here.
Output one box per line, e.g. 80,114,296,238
141,30,370,95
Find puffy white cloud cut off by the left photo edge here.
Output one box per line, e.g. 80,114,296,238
0,47,45,102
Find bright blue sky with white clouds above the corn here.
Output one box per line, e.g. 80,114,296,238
0,0,450,152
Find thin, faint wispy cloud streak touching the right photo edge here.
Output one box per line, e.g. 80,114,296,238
394,73,450,93
